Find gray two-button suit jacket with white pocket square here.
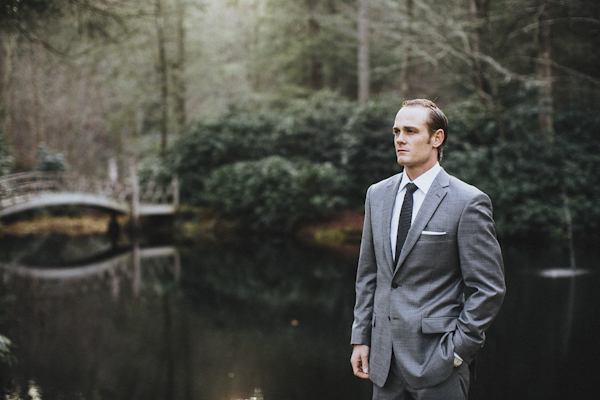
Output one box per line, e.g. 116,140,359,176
351,170,506,389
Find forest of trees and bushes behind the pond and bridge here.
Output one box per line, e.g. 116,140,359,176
0,0,600,243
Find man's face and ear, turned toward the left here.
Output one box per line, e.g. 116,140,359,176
394,106,444,179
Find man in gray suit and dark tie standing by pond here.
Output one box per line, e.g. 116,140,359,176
351,99,506,400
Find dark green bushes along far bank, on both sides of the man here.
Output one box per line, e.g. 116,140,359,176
165,93,600,241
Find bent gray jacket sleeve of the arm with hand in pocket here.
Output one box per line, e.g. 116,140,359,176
453,192,506,363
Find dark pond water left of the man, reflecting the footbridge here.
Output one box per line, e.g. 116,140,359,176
0,234,360,400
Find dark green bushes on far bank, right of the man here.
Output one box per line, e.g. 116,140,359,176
444,107,600,238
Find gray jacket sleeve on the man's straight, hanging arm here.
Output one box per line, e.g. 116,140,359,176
351,188,377,346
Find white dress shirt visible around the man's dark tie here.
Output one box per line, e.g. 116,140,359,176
390,162,442,260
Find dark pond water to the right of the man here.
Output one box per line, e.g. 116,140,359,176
475,244,600,399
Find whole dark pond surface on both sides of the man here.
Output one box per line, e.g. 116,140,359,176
0,231,600,400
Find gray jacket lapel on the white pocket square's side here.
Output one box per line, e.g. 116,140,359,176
396,169,450,272
